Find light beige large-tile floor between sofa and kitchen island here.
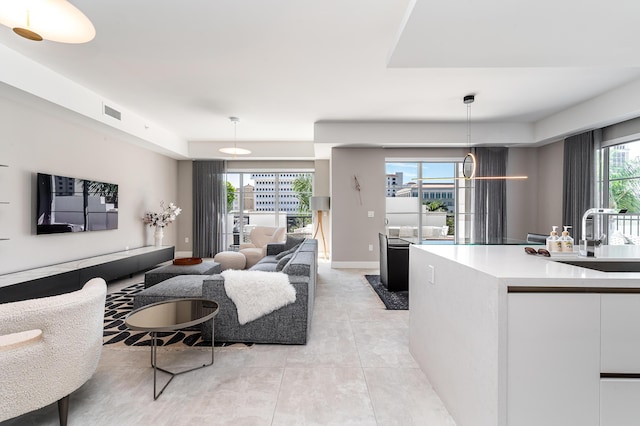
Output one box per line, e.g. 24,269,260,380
2,262,455,426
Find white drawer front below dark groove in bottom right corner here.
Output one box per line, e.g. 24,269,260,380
600,379,640,426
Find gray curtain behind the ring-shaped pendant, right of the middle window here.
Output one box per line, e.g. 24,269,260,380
472,148,509,244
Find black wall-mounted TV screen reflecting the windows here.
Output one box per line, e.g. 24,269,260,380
36,173,118,234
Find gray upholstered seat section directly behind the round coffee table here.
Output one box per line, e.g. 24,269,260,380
133,275,207,309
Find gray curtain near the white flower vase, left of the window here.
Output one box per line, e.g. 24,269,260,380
193,160,227,257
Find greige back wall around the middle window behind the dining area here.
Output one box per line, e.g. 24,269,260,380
331,148,544,268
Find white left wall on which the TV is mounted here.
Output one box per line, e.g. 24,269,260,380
0,89,181,274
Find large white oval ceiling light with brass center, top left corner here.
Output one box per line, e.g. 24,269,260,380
0,0,96,43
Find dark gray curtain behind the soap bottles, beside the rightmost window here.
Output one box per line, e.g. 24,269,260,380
559,130,600,239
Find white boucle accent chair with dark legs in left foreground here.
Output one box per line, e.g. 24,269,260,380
0,278,107,426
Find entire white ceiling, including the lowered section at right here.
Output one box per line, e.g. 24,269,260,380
0,0,640,151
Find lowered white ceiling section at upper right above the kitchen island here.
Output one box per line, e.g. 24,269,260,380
390,0,640,70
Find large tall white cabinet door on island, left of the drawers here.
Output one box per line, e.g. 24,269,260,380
507,293,600,426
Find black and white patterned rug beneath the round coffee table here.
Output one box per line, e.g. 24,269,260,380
103,283,240,347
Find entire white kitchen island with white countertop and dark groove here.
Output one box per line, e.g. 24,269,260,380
409,245,640,426
